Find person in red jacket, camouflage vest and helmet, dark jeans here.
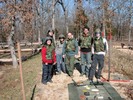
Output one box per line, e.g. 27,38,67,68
41,37,56,85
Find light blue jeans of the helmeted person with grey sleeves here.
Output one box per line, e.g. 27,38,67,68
56,54,66,73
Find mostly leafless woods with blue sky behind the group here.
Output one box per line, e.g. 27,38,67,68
0,0,133,67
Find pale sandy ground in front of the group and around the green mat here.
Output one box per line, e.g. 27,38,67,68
34,70,130,100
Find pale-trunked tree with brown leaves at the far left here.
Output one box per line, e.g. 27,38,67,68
1,0,33,68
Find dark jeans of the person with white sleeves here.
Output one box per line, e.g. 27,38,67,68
89,54,104,80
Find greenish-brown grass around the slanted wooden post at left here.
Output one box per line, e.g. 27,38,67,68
0,54,42,100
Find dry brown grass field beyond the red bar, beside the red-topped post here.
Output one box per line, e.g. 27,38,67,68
105,48,133,80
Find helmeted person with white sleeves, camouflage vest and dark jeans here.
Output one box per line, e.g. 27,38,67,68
89,29,108,84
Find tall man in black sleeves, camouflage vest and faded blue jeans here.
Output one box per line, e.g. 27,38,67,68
79,27,92,77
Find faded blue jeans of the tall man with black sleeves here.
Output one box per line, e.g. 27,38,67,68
81,52,92,76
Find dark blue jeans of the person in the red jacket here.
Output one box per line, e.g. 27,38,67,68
42,64,53,83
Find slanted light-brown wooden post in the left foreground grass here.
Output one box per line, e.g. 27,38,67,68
17,42,26,100
